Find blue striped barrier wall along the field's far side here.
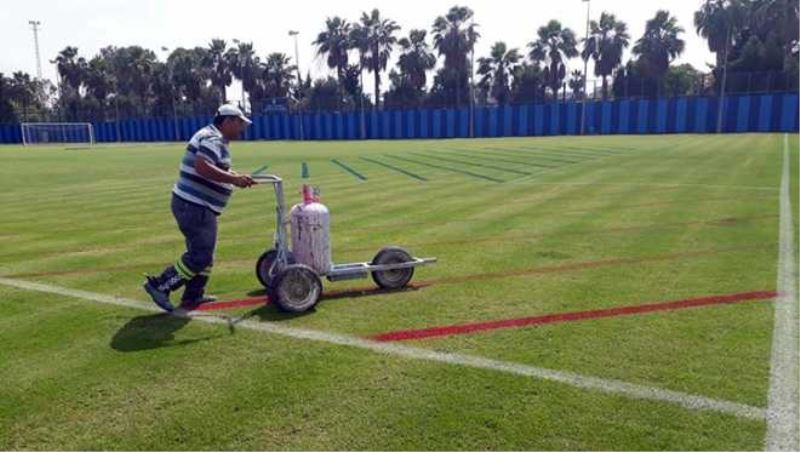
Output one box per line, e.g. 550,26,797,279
0,93,800,143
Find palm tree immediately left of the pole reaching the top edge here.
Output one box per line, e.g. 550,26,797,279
528,20,578,99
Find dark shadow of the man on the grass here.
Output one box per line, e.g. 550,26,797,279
111,314,220,352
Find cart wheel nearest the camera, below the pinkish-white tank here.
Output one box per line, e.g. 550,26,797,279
270,264,322,313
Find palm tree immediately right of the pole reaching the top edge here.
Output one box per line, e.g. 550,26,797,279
581,12,630,100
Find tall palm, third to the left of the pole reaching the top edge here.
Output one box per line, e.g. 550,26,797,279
433,6,480,107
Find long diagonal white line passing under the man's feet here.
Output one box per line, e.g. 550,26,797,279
0,277,766,421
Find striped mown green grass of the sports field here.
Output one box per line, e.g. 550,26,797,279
0,134,798,450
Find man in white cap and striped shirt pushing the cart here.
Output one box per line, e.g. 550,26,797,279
144,104,255,312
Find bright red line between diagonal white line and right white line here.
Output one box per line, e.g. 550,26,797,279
370,291,778,342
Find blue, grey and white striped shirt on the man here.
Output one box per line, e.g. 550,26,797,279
172,125,233,215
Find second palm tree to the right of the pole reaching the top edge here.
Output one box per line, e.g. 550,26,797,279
633,10,685,86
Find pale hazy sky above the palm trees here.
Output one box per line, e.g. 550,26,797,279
0,0,714,102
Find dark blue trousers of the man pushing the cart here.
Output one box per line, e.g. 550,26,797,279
172,194,217,275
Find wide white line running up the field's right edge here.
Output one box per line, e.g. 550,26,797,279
764,134,800,450
